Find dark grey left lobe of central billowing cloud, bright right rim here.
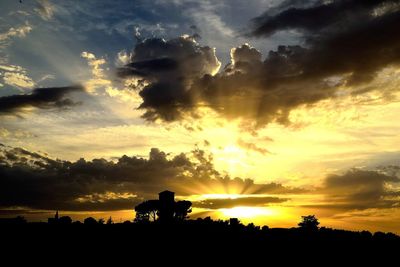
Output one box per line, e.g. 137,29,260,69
119,36,221,121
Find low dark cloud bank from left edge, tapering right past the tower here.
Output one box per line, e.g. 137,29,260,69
0,146,305,213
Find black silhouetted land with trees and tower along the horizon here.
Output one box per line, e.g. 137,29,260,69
0,192,400,260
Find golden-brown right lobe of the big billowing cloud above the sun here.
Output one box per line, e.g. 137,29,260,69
190,45,337,126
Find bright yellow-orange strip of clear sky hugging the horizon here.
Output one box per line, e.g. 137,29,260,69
16,206,400,234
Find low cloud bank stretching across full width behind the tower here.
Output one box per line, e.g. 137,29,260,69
0,146,400,211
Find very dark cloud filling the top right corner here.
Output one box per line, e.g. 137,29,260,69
252,0,400,84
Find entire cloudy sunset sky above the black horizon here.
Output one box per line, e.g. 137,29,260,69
0,0,400,233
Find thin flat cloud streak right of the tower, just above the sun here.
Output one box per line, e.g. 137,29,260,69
193,197,288,209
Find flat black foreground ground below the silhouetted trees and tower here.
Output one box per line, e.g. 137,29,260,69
0,221,400,266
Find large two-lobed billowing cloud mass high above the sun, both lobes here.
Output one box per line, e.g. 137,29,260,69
120,41,335,125
